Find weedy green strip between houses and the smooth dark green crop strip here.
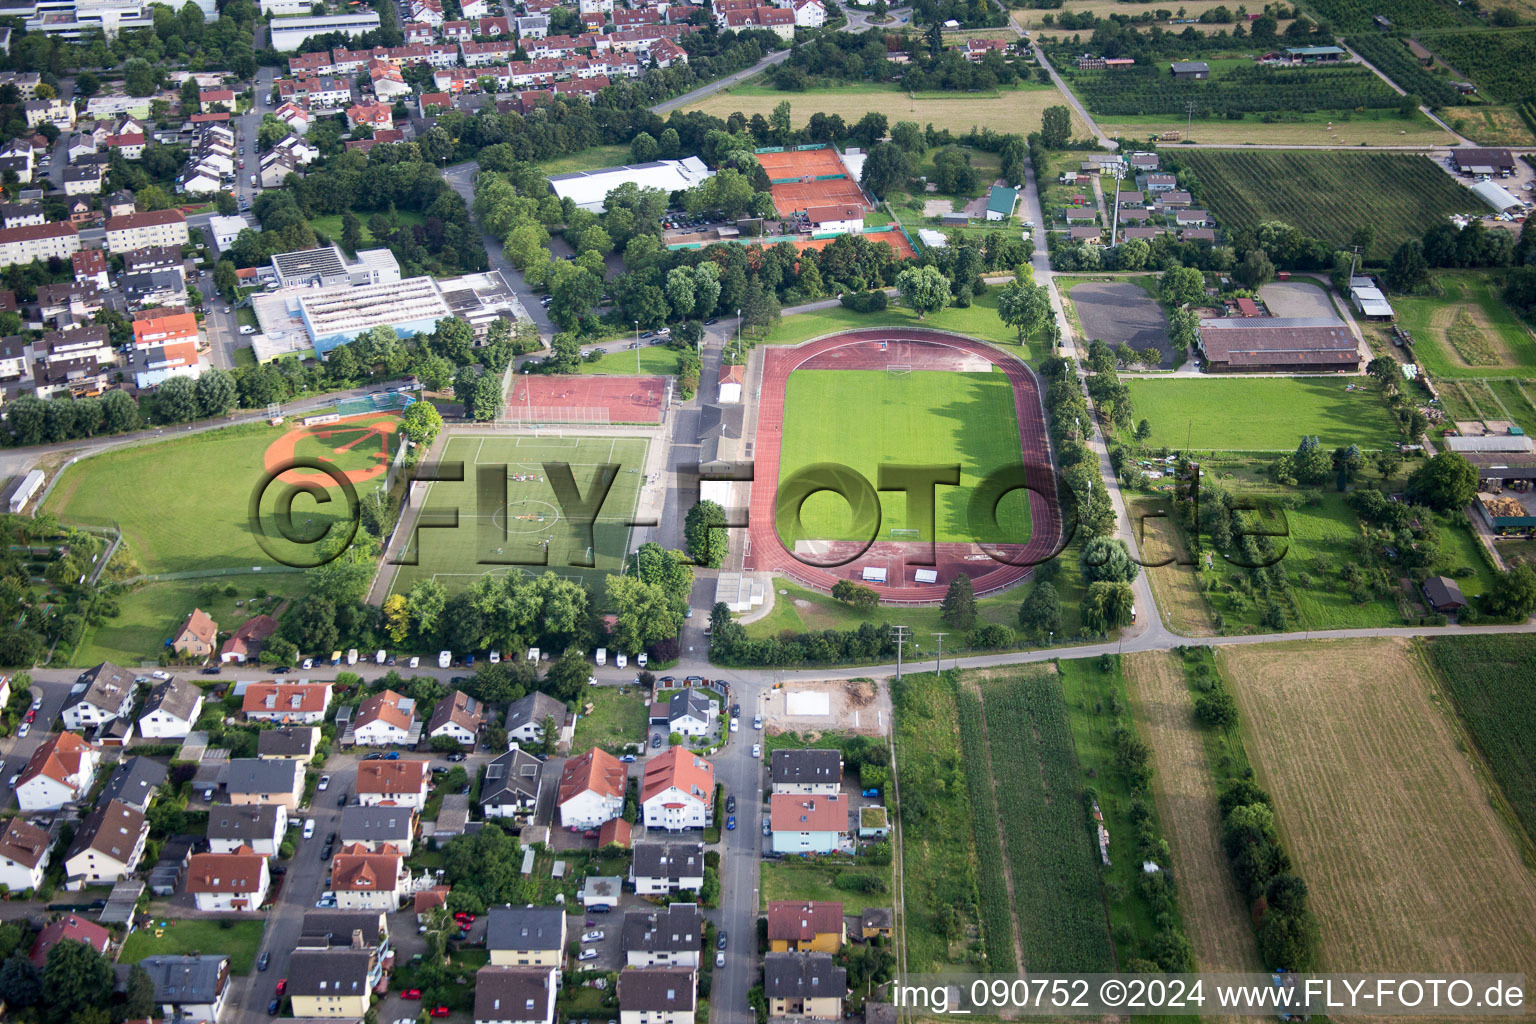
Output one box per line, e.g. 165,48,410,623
891,672,997,972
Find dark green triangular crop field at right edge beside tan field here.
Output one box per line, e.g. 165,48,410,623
1428,634,1536,840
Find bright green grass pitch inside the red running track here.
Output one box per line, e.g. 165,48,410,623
779,370,1029,547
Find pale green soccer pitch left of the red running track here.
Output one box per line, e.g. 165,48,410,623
390,434,650,594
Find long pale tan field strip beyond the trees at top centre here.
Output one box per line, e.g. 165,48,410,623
685,80,1089,138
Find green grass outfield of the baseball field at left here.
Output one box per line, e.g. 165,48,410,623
48,424,356,573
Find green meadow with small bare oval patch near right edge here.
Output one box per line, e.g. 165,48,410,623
1392,272,1536,378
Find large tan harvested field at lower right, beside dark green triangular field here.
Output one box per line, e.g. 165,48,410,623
1217,639,1536,973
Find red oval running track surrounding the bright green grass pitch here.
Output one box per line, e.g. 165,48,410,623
746,327,1061,603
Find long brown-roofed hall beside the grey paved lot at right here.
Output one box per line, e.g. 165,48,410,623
1200,316,1359,373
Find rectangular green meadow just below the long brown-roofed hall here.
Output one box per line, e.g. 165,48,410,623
1126,376,1398,451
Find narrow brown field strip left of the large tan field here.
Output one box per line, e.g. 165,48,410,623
1124,651,1264,972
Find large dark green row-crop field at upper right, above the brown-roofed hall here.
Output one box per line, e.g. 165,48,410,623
1178,149,1479,258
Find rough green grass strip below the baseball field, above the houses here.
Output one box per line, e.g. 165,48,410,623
71,573,304,666
